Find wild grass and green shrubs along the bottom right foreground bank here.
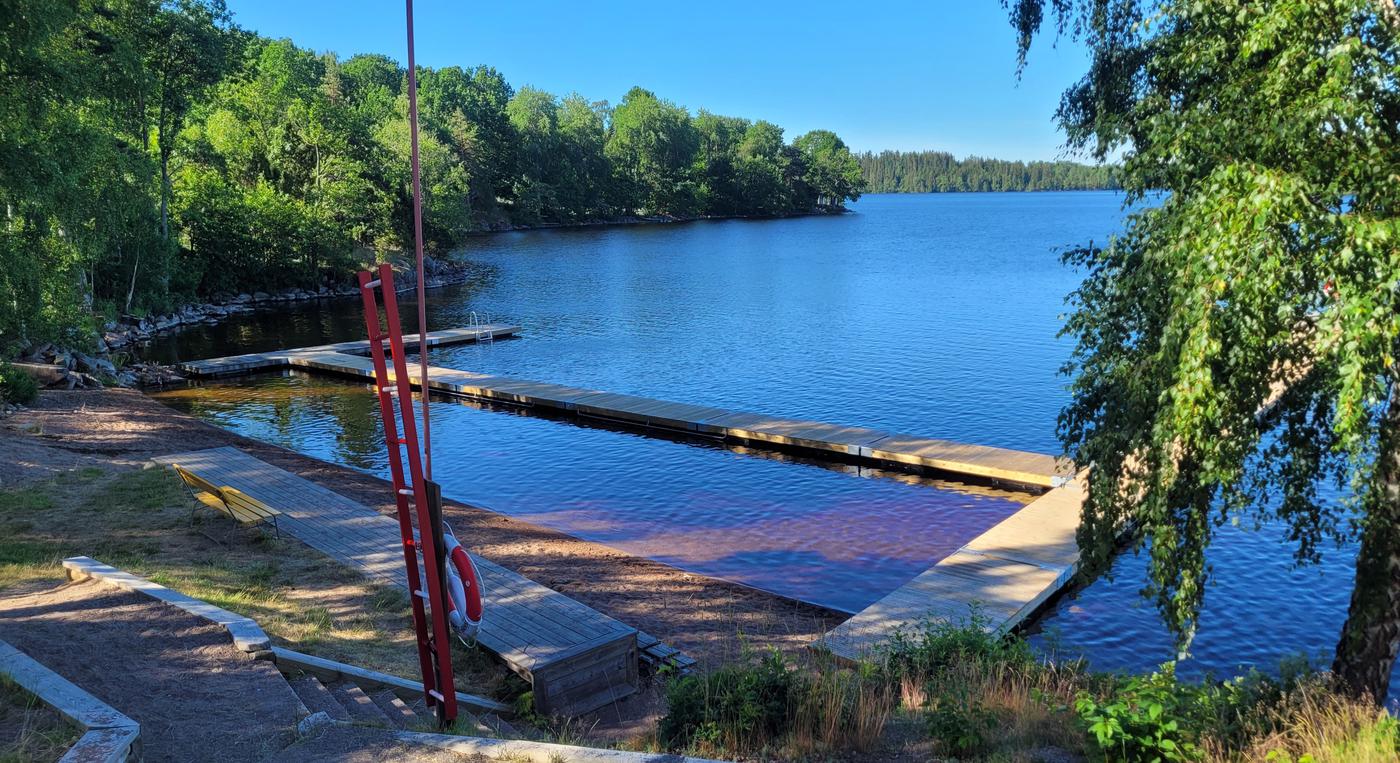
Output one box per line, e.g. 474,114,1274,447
657,617,1400,763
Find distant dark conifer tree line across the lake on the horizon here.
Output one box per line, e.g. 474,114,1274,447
855,151,1117,193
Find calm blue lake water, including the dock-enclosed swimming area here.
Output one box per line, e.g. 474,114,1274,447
148,192,1388,697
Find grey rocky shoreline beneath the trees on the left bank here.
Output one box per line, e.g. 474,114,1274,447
13,258,475,389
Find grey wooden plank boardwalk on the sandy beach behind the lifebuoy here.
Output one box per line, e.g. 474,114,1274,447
154,447,693,714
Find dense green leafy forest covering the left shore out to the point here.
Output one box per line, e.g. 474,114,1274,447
0,0,864,351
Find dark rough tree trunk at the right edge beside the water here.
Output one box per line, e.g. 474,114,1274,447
1331,374,1400,704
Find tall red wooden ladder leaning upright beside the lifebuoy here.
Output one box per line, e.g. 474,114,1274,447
352,265,456,725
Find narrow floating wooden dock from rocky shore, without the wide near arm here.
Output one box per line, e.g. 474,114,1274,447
181,326,1071,490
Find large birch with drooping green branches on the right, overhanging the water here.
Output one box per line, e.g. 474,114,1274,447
1012,0,1400,700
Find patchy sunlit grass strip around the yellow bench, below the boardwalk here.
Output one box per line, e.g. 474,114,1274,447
0,468,507,693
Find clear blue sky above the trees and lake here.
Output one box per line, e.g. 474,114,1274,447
228,0,1086,160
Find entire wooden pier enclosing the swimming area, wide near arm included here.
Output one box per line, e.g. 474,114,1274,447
183,326,1103,659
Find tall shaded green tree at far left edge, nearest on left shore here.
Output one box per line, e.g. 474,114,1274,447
0,0,173,346
